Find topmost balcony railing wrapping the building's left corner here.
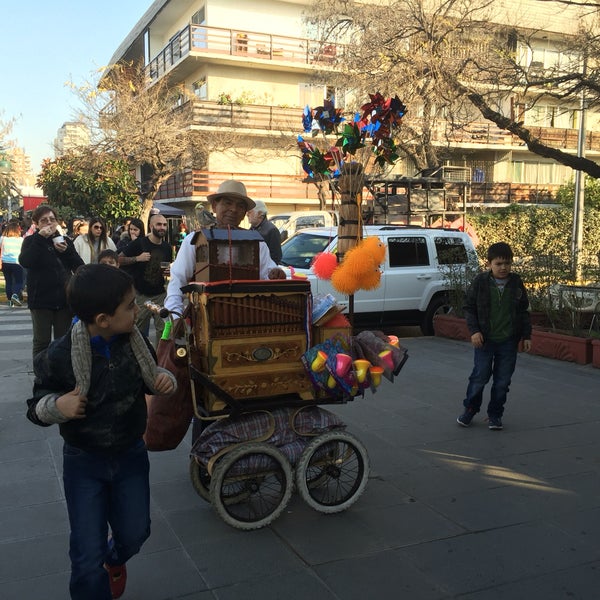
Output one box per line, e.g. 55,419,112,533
147,25,343,81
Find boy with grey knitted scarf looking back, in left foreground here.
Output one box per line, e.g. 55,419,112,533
27,264,177,600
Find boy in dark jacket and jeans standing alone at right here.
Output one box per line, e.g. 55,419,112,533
456,242,531,430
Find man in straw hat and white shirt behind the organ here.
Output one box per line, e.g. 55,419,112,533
165,179,286,314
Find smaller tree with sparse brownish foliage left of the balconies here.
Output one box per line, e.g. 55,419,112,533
70,64,234,220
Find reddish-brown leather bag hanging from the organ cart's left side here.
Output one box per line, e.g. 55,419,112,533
144,319,194,451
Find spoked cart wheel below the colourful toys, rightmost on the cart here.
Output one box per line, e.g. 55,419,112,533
296,431,369,513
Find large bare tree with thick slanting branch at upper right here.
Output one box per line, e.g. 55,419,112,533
309,0,600,177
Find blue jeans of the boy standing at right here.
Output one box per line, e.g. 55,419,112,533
463,339,518,417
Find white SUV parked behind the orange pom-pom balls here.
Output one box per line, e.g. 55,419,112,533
281,225,478,335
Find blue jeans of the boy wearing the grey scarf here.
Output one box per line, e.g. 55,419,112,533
63,440,150,600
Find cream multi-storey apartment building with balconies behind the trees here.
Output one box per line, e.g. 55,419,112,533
111,0,600,213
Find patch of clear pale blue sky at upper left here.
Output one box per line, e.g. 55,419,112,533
0,0,152,173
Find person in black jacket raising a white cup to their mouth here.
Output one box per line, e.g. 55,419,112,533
19,204,83,356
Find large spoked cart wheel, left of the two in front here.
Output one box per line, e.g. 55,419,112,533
210,442,293,530
